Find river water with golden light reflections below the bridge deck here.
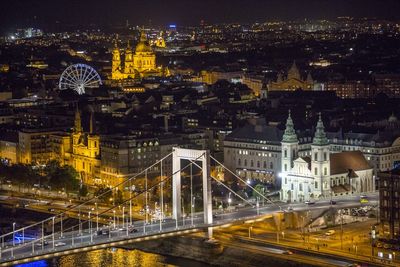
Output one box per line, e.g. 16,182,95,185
12,249,210,267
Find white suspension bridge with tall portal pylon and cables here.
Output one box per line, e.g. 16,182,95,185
0,148,360,266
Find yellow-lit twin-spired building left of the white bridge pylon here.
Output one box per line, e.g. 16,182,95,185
71,110,101,185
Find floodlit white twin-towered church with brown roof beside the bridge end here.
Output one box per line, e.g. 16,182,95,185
280,112,375,202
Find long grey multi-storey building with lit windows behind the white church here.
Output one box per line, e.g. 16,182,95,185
223,112,400,186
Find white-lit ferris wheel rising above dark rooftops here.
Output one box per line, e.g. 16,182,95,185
58,64,103,95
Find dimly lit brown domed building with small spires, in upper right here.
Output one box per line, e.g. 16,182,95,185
268,62,314,91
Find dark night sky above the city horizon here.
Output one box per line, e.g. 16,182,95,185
0,0,400,30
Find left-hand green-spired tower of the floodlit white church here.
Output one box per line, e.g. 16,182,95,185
281,110,299,174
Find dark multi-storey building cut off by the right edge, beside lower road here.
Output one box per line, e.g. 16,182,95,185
378,166,400,240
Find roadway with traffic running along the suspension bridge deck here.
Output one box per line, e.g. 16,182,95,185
1,195,377,262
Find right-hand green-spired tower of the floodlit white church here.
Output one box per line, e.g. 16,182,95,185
311,113,331,197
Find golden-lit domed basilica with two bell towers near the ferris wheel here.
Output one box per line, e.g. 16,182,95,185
111,32,169,80
